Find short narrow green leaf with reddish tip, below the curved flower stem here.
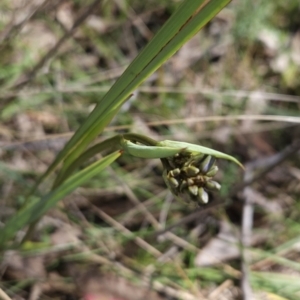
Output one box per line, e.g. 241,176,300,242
0,151,122,248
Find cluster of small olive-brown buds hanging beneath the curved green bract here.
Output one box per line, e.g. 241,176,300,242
164,151,221,205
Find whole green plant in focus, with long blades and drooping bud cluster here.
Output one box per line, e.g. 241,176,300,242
0,0,239,247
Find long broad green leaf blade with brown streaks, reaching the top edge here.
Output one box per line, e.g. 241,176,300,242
35,0,230,185
